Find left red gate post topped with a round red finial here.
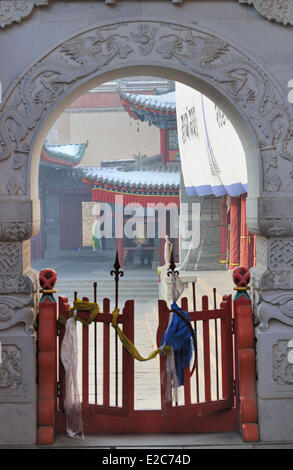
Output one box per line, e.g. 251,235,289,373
37,269,57,444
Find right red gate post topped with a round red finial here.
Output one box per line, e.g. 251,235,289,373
233,268,259,442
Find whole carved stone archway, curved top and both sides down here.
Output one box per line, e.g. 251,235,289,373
0,19,293,439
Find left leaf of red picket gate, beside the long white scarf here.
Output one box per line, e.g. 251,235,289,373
58,297,134,415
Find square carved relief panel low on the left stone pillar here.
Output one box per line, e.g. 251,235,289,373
0,344,22,391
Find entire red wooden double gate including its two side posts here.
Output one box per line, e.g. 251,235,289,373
38,266,258,444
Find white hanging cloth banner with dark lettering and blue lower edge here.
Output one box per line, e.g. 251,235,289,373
176,83,247,197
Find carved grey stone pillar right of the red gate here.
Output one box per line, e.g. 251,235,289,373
248,197,293,441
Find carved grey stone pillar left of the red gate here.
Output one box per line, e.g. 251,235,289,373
0,202,37,445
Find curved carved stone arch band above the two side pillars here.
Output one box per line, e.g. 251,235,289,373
0,19,293,209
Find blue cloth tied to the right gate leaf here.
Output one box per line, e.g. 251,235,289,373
160,302,195,386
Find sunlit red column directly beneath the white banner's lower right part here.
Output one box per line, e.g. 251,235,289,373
229,197,241,269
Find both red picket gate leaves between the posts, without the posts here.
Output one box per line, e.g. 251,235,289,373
56,296,238,434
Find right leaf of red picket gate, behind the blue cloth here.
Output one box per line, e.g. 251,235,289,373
157,296,235,412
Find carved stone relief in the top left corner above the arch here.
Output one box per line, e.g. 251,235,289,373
0,0,48,28
